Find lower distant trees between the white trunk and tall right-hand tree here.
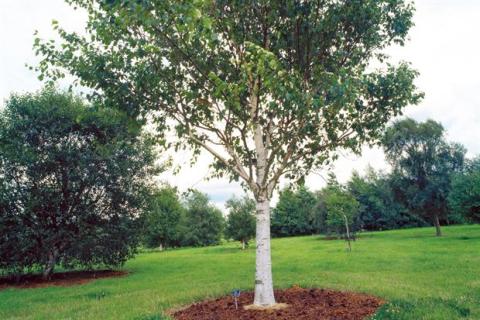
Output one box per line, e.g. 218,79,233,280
272,168,428,237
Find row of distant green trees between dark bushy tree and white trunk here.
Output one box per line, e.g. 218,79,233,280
142,185,255,250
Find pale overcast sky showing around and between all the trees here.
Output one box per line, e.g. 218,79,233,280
0,0,480,208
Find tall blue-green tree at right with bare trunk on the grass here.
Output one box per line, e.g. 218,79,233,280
383,118,465,236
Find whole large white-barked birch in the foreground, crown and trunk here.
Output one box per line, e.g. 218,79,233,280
35,0,421,306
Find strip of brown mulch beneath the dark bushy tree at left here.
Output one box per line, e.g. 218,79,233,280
0,270,128,290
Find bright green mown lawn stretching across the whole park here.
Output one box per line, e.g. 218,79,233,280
0,226,480,320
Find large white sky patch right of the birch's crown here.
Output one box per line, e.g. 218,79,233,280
392,0,480,156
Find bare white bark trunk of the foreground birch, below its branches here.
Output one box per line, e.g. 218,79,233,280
253,199,275,307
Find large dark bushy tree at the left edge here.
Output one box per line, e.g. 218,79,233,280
0,89,156,278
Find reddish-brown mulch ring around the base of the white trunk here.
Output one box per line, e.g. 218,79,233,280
170,286,385,320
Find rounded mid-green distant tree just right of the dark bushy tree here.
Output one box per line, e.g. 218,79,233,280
143,185,185,250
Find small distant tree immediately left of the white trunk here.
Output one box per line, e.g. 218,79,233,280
225,196,255,250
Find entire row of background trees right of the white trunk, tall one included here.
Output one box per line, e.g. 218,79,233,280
272,118,480,237
